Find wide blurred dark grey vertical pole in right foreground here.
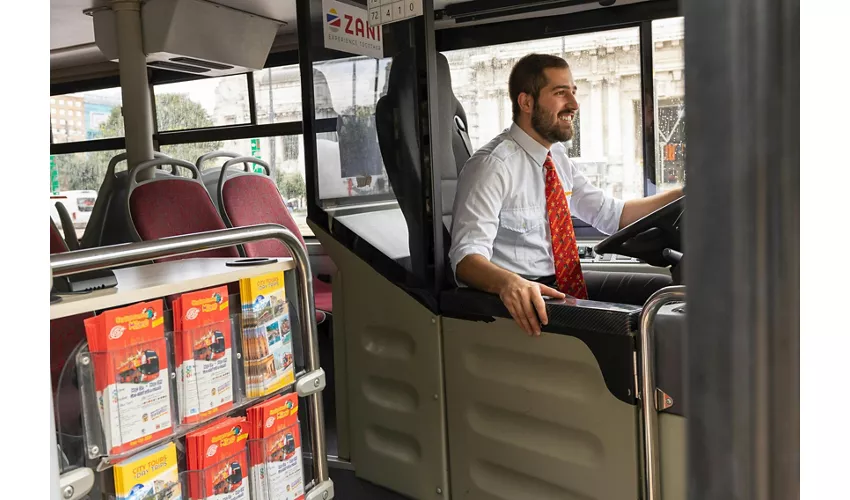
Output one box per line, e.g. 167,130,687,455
683,0,800,500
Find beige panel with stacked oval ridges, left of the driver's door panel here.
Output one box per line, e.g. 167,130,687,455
317,227,448,499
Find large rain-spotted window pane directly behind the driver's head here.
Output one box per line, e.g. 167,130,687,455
445,28,643,200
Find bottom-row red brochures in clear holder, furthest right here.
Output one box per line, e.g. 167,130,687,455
248,421,305,500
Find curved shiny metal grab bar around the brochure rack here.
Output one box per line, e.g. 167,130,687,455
50,224,332,498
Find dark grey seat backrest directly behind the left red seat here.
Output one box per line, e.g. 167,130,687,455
79,151,172,248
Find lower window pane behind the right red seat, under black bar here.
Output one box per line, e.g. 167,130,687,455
160,135,313,236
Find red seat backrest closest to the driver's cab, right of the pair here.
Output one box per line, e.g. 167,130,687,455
222,175,307,257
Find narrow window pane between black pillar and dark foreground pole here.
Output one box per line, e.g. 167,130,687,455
652,17,686,191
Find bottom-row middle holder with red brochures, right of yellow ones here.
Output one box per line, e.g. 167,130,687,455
182,449,256,500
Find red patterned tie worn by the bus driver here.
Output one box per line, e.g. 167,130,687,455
543,153,587,299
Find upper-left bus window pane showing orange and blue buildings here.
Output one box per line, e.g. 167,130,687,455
50,88,124,143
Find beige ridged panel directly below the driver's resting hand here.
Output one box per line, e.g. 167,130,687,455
442,318,640,500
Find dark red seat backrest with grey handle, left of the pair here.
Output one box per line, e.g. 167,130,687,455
127,158,239,262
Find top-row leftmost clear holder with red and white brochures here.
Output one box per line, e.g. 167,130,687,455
77,333,178,471
